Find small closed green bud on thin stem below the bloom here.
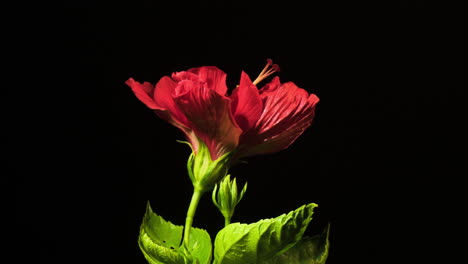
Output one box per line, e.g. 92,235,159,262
211,175,247,225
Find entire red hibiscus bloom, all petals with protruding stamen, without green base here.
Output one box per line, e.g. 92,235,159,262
126,60,319,160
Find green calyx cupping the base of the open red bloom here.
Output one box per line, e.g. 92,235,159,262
187,140,231,192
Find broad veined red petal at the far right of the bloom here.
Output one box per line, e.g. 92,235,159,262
242,82,318,156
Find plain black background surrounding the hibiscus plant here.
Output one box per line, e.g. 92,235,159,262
11,1,466,264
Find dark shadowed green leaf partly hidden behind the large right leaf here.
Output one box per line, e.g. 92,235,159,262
259,225,330,264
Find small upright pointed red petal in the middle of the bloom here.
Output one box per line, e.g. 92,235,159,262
231,72,263,132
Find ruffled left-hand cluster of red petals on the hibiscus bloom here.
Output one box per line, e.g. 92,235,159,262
126,67,242,160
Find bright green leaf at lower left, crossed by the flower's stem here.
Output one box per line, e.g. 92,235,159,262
138,203,211,264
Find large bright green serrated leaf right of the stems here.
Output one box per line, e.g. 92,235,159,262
214,203,317,264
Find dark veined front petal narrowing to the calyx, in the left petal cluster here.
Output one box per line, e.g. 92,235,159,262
174,82,242,160
